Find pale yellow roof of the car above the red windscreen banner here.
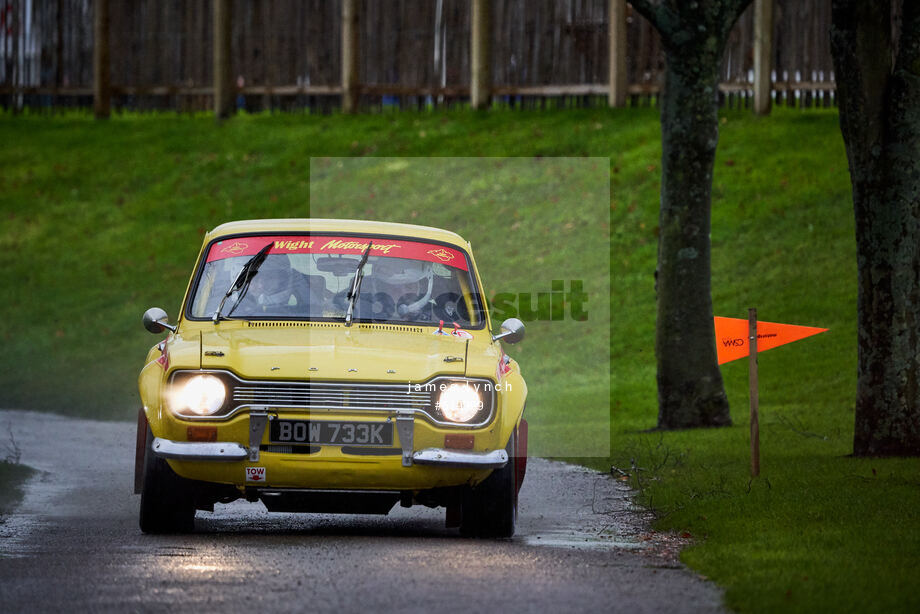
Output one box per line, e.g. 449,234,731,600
205,218,468,247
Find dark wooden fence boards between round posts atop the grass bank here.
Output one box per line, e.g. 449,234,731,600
0,0,834,110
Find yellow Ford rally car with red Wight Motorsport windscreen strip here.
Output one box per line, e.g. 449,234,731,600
135,219,527,536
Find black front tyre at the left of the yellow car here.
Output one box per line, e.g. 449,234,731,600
140,426,195,534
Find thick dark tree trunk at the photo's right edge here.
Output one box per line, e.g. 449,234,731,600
831,0,920,456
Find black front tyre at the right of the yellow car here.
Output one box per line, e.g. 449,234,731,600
460,430,518,537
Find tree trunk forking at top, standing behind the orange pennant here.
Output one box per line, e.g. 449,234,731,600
632,0,751,429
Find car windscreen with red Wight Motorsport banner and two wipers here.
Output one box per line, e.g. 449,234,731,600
188,235,484,328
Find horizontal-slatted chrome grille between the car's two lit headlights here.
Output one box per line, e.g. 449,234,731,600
233,382,431,410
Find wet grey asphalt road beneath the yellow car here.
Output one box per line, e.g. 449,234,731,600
0,411,722,614
